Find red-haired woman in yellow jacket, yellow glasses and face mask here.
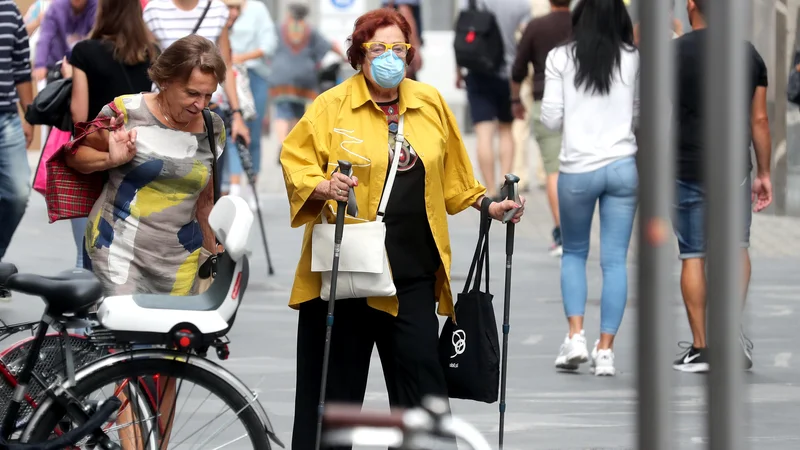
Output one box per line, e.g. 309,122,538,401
281,8,524,449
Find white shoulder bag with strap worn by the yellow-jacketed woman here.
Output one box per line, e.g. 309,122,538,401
311,116,405,301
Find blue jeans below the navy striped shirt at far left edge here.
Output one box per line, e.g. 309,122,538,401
0,113,31,260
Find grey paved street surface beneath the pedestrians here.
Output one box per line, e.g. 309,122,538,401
6,136,800,450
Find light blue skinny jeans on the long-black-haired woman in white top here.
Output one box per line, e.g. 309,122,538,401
558,157,639,334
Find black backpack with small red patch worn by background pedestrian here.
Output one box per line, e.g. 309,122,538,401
453,0,505,75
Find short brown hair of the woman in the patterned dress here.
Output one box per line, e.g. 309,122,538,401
148,34,227,87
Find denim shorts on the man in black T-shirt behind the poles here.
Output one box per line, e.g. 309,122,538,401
672,175,753,259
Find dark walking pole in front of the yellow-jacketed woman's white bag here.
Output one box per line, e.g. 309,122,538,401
316,160,353,450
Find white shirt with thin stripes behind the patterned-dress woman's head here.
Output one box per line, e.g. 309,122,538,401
144,0,228,50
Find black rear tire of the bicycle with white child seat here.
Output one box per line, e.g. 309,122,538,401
24,356,272,450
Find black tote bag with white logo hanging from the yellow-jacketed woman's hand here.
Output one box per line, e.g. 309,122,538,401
439,198,500,403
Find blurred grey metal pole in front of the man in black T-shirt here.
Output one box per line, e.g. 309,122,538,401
705,0,750,450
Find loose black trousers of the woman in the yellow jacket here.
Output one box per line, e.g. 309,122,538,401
292,278,447,450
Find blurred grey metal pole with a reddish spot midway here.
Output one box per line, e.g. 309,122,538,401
637,0,675,450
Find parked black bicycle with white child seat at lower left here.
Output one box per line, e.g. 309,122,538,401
0,197,283,450
